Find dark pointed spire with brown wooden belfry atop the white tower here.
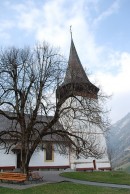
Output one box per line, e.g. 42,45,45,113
56,38,99,99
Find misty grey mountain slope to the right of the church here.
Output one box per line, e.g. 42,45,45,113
107,113,130,169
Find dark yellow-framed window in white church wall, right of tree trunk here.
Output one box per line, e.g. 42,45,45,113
45,143,54,161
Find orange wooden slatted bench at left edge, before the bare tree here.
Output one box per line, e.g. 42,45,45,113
0,172,27,182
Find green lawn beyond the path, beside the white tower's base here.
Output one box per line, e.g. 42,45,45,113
61,171,130,185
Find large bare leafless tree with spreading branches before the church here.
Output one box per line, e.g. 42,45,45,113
0,42,108,176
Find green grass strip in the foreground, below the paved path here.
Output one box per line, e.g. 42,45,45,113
0,182,130,194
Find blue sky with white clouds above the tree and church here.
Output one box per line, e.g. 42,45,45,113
0,0,130,122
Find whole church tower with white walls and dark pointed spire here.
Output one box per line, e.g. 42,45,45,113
56,32,110,170
